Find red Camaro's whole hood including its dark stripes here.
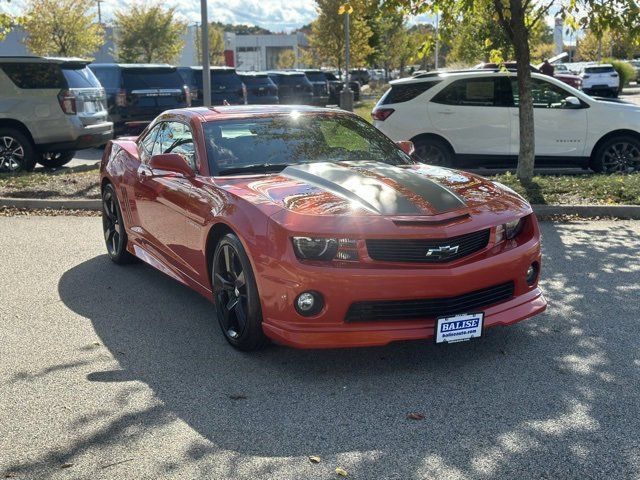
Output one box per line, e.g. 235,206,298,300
217,162,530,216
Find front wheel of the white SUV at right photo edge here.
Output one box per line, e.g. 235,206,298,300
590,135,640,173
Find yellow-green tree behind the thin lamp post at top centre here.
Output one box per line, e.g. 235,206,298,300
309,0,372,71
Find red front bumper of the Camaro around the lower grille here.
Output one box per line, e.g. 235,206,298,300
257,231,547,348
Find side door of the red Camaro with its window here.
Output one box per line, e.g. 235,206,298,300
134,121,195,273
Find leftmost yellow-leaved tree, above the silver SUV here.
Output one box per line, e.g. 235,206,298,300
20,0,104,57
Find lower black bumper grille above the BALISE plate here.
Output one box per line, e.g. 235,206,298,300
345,282,514,322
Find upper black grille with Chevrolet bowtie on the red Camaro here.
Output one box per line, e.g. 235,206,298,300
366,229,490,263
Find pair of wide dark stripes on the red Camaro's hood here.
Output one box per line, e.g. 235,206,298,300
281,162,466,215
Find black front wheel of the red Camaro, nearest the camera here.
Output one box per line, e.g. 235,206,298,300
211,233,269,352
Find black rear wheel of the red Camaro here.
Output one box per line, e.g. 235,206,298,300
102,184,136,265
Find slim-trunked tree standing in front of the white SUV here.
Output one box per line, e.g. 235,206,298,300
383,0,640,182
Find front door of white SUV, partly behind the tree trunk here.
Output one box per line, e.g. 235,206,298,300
510,78,588,157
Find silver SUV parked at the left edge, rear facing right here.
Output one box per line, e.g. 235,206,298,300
0,57,113,172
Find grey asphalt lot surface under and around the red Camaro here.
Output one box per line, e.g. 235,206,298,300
0,217,640,479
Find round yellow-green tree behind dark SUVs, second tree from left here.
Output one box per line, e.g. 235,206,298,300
114,4,187,63
